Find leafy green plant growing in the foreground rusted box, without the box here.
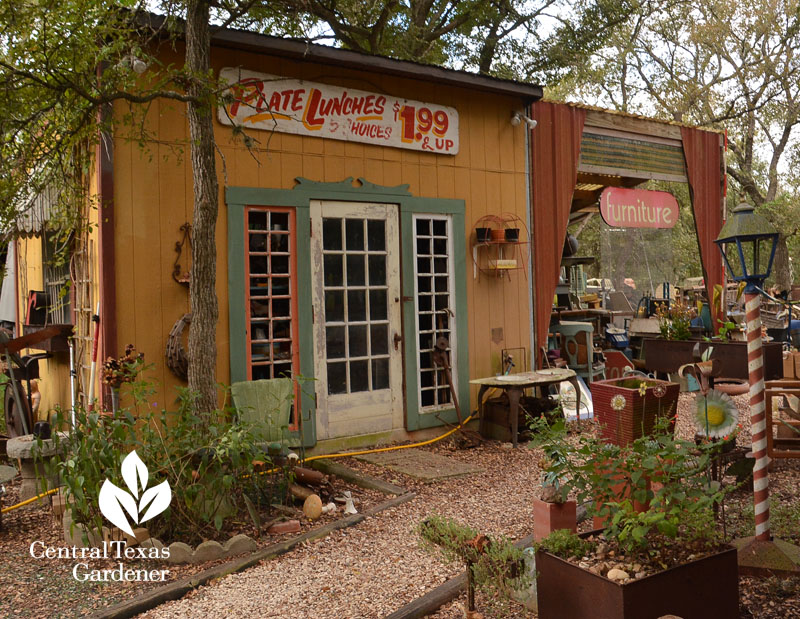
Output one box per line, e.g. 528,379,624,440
531,420,727,551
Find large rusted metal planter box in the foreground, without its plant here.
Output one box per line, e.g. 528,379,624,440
536,534,739,619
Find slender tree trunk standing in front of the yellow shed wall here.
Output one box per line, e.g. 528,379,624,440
186,0,219,414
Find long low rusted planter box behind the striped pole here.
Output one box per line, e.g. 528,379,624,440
642,338,783,380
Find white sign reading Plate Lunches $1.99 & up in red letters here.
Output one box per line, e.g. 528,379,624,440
219,68,458,155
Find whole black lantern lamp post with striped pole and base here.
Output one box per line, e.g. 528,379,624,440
714,203,797,573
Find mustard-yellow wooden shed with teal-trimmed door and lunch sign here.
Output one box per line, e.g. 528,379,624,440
9,30,722,451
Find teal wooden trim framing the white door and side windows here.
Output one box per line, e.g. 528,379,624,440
225,177,469,447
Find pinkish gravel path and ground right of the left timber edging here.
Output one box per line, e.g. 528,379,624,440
142,394,800,619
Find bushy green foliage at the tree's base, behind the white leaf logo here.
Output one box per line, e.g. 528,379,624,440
41,372,294,542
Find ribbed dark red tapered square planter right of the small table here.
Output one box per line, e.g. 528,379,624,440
589,378,681,446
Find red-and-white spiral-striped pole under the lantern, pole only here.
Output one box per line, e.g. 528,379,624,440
744,291,770,542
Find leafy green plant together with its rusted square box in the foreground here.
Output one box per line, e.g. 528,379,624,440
534,420,739,619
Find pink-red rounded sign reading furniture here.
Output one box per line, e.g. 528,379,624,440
600,187,680,228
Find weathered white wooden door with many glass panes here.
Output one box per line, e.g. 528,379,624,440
311,201,403,439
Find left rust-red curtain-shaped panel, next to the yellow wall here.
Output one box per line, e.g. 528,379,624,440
530,101,586,359
